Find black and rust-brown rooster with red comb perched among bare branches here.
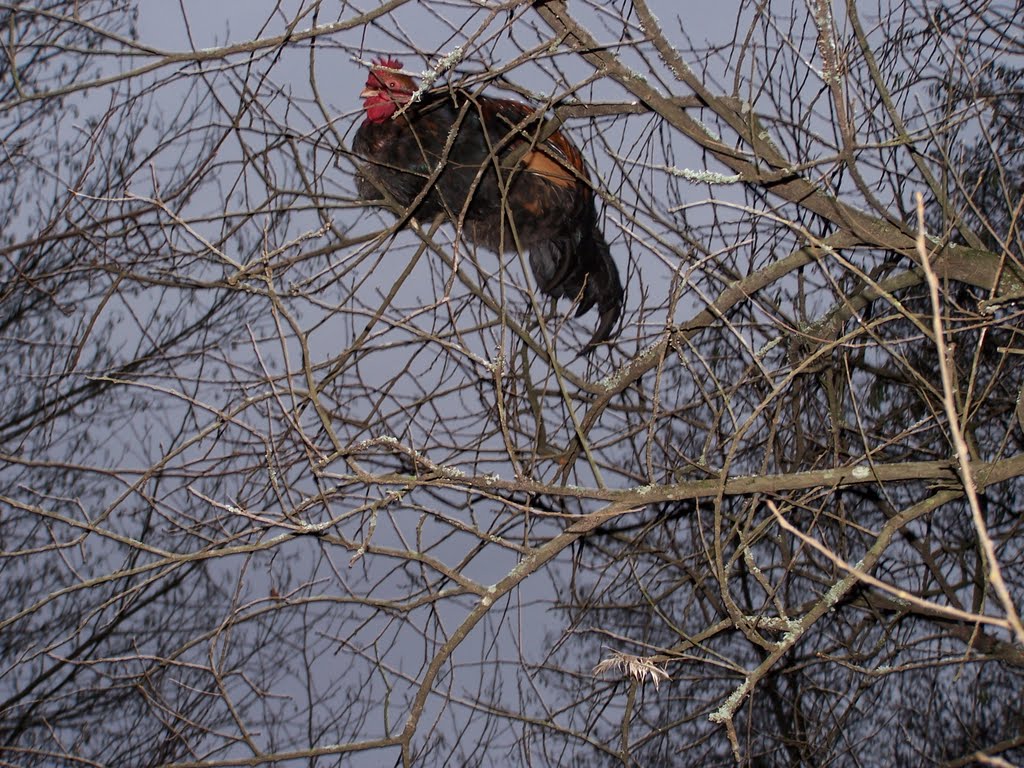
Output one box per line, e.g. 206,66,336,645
352,59,623,352
